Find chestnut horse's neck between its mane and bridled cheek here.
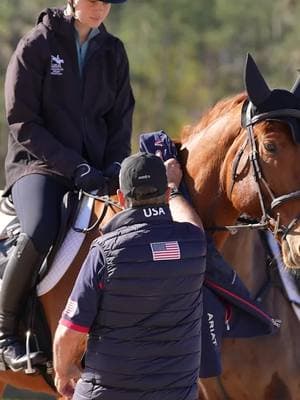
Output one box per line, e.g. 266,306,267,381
182,110,241,247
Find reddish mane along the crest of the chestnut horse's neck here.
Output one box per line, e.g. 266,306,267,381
180,93,247,143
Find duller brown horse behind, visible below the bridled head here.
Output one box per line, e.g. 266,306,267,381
209,230,300,400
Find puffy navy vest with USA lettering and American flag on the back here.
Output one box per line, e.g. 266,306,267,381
85,206,206,400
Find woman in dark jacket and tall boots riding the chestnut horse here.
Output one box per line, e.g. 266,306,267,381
0,0,134,370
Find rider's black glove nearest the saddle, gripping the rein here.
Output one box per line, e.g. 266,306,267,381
74,164,105,192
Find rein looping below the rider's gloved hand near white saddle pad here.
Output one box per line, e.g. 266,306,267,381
72,190,123,233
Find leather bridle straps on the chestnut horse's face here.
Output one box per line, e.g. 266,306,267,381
209,100,300,239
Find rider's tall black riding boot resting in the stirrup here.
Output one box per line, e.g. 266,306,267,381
0,233,45,370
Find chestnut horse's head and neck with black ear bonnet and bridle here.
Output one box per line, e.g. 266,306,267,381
183,55,300,268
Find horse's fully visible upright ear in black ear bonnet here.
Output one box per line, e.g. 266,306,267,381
244,53,271,106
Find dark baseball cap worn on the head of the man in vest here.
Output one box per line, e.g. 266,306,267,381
120,152,168,200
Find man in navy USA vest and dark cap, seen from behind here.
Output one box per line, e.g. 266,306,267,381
54,153,206,400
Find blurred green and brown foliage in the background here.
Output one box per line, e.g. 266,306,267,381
0,0,300,186
